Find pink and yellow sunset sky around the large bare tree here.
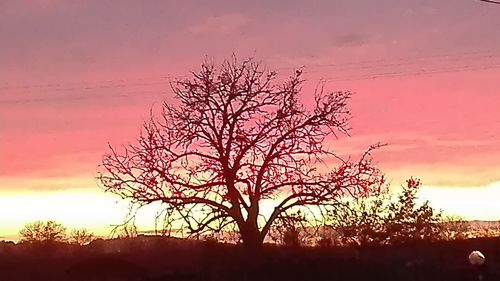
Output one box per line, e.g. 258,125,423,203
0,0,500,239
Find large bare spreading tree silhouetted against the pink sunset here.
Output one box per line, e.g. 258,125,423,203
98,58,384,247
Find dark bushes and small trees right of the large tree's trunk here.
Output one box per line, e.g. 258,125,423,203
271,179,500,246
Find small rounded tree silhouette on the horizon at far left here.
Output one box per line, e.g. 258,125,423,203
19,221,67,242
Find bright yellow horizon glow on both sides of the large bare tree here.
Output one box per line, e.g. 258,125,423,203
0,182,500,240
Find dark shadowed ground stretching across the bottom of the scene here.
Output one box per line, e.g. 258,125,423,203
0,237,500,281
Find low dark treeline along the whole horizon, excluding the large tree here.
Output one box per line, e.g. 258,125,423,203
6,179,500,247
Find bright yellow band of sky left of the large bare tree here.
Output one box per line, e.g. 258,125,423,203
0,190,126,239
